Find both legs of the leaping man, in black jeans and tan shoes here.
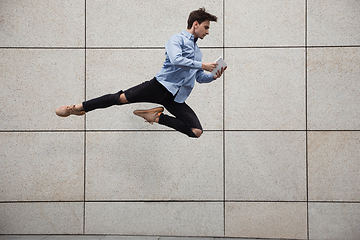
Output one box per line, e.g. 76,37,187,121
56,78,202,137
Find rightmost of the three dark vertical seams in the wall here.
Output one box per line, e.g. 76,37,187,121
305,0,310,239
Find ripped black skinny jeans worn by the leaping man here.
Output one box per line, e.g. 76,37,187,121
83,78,202,137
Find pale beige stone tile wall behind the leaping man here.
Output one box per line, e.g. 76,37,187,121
0,0,360,239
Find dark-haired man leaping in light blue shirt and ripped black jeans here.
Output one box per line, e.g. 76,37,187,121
55,8,226,137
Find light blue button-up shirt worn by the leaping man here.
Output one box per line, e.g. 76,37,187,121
155,30,214,103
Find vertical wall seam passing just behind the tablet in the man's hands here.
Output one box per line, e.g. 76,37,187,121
222,0,226,237
